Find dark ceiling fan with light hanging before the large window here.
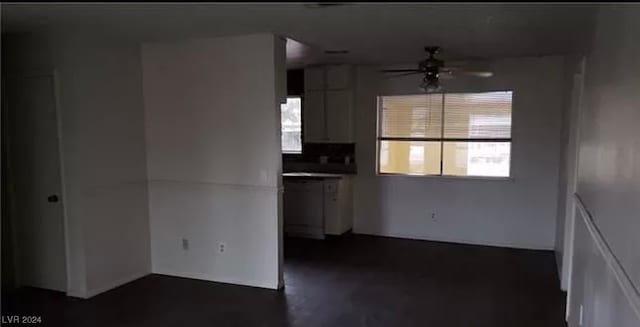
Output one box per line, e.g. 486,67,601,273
382,46,493,92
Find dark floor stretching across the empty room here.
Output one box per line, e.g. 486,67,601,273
2,236,565,327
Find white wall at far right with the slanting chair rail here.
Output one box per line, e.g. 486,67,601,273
569,6,640,327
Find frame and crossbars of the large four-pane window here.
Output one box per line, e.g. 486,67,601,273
375,90,515,181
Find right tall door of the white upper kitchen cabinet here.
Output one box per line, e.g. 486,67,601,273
326,90,353,143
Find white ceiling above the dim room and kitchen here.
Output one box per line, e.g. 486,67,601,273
2,3,593,66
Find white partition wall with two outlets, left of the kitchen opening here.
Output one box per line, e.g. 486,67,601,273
142,34,286,288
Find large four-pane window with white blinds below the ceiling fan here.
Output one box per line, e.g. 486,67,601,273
378,91,512,177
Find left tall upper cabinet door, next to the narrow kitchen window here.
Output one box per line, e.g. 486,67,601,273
302,91,327,143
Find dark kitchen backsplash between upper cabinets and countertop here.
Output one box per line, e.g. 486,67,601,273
282,143,356,174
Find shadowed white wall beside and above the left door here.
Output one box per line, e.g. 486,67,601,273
5,30,150,297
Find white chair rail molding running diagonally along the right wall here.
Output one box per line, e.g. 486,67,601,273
575,194,640,319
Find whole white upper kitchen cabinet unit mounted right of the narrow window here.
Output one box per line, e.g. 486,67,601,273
302,65,355,143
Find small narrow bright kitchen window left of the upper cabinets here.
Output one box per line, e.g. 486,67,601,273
280,97,302,153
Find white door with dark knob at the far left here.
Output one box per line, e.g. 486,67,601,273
3,76,66,291
